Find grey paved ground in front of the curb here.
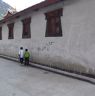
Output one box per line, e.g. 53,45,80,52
0,58,95,96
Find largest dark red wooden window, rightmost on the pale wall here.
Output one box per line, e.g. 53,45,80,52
45,8,63,37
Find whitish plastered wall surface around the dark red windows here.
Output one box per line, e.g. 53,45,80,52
0,0,95,74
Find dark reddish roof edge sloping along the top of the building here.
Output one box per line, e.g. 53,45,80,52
0,0,64,24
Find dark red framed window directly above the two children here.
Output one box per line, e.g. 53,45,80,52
22,17,31,38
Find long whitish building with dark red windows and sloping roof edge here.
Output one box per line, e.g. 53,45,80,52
0,0,95,74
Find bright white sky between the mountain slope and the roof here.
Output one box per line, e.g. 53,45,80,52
2,0,44,11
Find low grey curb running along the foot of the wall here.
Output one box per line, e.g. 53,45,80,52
0,55,95,85
